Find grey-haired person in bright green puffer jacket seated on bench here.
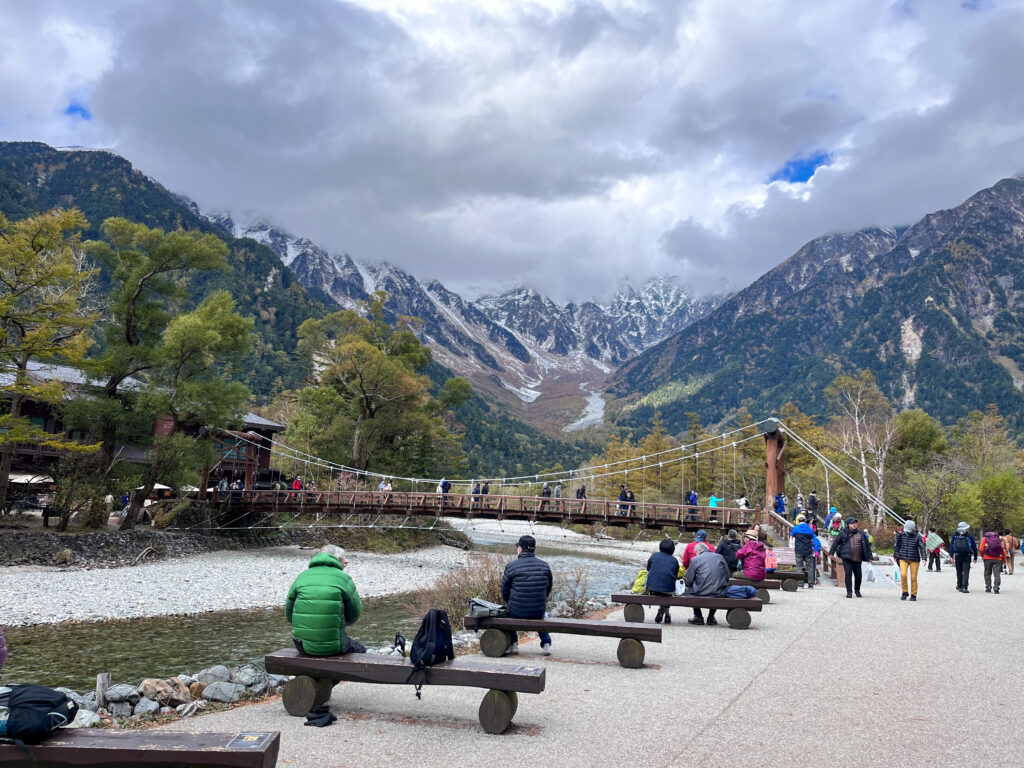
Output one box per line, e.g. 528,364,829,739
285,544,367,656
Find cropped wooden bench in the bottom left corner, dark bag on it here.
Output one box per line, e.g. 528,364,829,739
0,728,281,768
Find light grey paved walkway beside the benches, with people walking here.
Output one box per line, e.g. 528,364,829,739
157,563,1024,768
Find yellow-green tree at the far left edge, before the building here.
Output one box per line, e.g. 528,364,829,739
0,210,95,508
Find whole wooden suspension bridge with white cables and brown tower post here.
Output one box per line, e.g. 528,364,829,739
176,418,902,537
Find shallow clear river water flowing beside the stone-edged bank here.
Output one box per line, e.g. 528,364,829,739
0,536,636,691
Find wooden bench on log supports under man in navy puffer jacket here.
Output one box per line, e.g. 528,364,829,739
462,616,662,670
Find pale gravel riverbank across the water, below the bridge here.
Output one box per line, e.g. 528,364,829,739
0,547,468,626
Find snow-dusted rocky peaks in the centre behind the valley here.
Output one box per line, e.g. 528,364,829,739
209,214,724,430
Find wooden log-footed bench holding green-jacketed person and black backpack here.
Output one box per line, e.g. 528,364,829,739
263,648,546,733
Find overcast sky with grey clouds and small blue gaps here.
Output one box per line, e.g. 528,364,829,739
0,0,1024,300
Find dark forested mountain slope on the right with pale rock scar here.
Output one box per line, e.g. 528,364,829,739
608,178,1024,430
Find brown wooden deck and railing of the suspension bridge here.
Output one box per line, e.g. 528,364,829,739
213,490,763,532
